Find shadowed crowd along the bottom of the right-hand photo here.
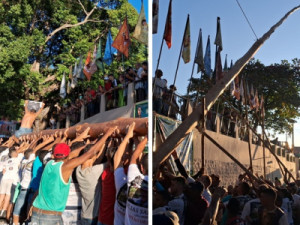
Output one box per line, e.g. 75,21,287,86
153,150,300,225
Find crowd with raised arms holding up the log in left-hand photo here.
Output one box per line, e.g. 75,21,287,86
0,122,148,225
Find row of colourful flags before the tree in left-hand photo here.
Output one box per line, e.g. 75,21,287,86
60,1,148,98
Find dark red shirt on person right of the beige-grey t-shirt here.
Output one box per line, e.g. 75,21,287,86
98,167,116,225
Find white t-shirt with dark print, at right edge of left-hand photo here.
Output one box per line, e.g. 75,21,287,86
125,164,148,225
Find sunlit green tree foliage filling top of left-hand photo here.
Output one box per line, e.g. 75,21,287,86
0,0,147,119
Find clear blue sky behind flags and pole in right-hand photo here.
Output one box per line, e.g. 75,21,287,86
152,0,300,146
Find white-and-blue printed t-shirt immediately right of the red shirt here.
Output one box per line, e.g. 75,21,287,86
114,167,127,225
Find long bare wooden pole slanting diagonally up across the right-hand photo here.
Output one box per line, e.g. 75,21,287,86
153,5,300,171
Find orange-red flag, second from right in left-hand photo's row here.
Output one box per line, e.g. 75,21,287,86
112,17,131,58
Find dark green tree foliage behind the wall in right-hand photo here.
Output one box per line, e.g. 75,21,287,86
190,59,300,133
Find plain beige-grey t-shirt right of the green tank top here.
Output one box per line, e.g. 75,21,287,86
76,164,105,219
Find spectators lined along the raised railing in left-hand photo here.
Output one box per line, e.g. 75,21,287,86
49,61,148,129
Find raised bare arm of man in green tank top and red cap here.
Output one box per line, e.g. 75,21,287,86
62,127,117,182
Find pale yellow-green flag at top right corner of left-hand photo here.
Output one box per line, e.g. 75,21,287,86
132,1,148,45
